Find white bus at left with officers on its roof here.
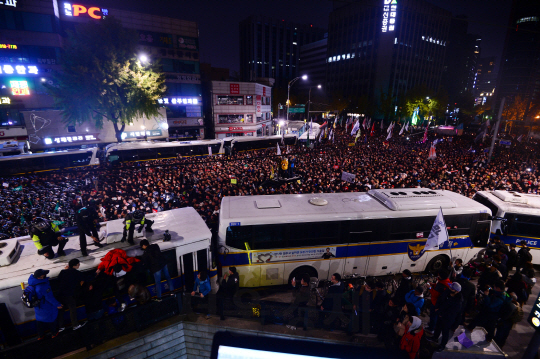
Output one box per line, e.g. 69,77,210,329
0,207,213,338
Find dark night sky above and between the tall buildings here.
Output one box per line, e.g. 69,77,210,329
100,0,511,75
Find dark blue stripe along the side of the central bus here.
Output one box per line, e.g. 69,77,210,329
219,236,472,267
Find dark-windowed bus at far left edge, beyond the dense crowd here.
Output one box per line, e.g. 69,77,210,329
0,147,99,175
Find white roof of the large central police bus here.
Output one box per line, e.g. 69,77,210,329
220,188,491,225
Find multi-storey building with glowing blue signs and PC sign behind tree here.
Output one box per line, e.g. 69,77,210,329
0,0,204,148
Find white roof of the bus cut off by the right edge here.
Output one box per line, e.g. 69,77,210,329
476,190,540,216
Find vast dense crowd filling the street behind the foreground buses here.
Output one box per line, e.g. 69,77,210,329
0,122,540,238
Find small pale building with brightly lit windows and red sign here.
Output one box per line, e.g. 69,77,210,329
212,81,273,139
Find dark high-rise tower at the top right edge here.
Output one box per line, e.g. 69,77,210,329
496,0,540,117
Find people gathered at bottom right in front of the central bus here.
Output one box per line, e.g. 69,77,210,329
304,237,536,359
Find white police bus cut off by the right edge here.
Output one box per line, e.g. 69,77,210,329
473,190,540,264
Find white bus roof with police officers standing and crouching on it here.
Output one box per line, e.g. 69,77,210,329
0,207,212,290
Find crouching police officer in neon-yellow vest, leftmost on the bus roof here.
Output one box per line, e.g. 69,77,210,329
30,217,68,259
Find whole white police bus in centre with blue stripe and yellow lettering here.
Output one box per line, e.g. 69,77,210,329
216,188,491,287
